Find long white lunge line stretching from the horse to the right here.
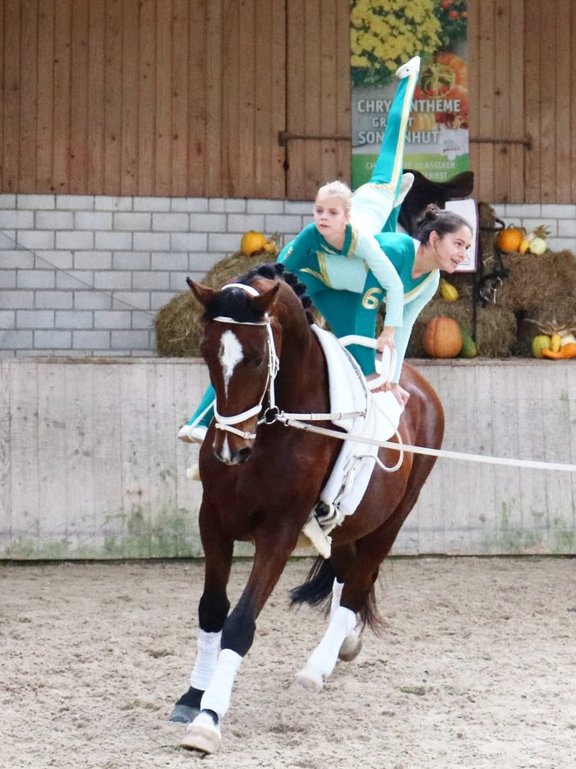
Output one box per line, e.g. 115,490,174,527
278,414,576,473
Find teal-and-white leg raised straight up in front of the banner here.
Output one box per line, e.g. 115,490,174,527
351,56,420,235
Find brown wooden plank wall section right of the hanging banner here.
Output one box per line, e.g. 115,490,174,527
468,0,576,203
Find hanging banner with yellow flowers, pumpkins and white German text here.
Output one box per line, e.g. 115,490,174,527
351,0,470,189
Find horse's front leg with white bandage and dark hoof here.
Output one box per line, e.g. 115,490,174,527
169,508,234,724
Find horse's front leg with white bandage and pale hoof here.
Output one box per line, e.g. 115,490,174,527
181,532,297,753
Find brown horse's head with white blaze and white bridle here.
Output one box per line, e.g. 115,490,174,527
187,280,280,465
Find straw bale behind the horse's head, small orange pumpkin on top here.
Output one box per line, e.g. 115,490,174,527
155,251,275,358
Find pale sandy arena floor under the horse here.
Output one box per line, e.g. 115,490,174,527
0,558,576,769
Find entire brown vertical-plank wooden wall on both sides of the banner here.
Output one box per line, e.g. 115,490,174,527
0,0,576,203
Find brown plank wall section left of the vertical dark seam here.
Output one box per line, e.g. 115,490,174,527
0,0,286,197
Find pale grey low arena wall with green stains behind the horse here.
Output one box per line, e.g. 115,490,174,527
0,358,576,560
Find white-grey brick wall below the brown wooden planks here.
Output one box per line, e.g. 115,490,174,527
0,194,576,358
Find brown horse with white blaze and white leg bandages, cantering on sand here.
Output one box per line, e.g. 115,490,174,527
171,265,444,753
